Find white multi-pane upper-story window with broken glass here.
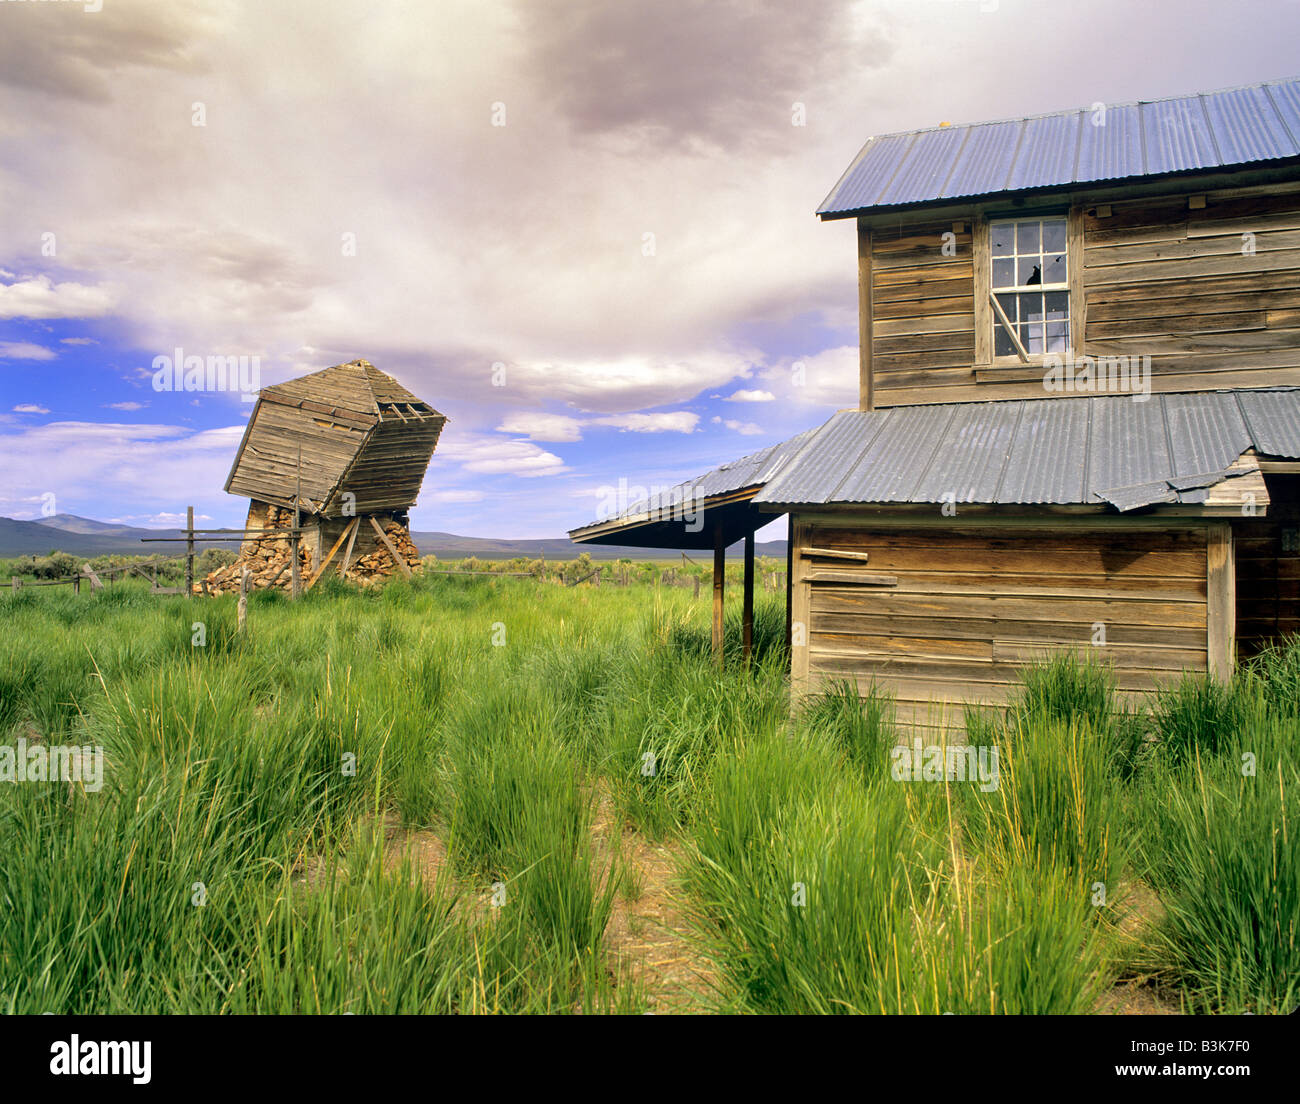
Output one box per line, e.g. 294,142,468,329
988,216,1070,356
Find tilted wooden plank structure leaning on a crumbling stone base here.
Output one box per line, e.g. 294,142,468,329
226,360,446,585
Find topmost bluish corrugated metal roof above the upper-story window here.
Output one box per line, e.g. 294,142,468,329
818,78,1300,217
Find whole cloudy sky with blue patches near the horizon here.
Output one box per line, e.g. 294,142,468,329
0,0,1300,537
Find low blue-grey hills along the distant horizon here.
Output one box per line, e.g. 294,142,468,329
0,514,785,563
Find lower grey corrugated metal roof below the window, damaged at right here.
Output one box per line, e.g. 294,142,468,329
754,388,1300,510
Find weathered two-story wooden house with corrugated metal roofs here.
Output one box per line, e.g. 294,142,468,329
572,79,1300,716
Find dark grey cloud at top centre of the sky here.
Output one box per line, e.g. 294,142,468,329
519,0,891,150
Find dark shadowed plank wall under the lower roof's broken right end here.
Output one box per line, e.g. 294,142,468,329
1232,475,1300,659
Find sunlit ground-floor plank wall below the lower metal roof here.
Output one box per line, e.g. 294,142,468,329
794,521,1208,723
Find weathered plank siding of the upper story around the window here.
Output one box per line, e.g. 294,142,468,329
871,183,1300,407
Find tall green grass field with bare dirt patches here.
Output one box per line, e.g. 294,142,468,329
0,576,1300,1013
